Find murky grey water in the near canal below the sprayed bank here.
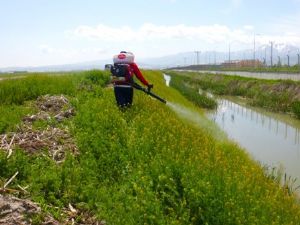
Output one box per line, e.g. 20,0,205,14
207,99,300,187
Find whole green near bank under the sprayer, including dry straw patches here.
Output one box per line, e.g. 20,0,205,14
0,71,300,225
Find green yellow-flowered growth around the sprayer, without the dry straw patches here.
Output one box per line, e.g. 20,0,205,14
0,71,300,225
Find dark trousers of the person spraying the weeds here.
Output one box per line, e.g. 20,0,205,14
114,86,133,108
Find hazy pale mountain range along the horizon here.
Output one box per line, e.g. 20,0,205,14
0,44,300,72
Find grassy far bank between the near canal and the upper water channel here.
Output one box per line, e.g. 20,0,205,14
170,72,300,118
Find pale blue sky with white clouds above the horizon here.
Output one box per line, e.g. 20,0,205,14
0,0,300,67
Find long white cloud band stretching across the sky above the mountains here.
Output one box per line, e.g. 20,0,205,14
68,23,247,42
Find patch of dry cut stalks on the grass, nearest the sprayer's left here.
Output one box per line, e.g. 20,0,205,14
0,95,79,163
